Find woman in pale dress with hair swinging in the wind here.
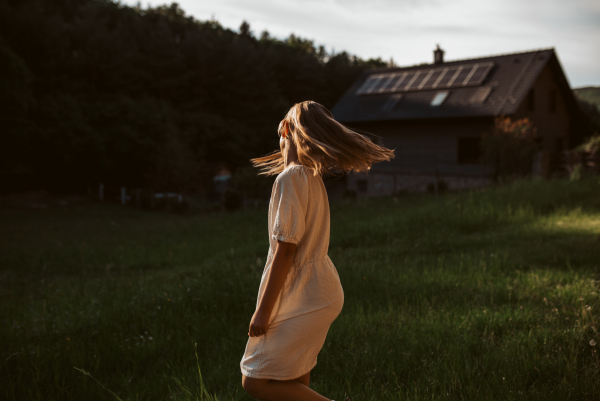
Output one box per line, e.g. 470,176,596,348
240,101,394,401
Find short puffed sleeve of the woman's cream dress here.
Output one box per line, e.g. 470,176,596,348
271,167,309,244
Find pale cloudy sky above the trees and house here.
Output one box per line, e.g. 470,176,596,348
124,0,600,87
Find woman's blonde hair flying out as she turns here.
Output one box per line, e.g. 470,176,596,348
250,101,394,175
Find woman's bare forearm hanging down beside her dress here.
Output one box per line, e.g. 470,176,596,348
248,241,296,337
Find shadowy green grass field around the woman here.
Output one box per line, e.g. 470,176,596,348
0,178,600,401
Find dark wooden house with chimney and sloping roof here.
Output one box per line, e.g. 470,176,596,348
332,46,584,196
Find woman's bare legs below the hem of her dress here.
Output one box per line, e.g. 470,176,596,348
242,373,330,401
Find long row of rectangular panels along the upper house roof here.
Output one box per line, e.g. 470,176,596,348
356,61,494,95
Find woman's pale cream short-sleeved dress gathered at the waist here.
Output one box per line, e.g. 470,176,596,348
240,165,344,380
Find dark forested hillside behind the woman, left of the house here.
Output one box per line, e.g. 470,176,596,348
0,0,385,192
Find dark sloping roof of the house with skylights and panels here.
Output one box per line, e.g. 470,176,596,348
332,49,576,122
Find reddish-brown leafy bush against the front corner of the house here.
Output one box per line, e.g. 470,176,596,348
481,117,538,180
